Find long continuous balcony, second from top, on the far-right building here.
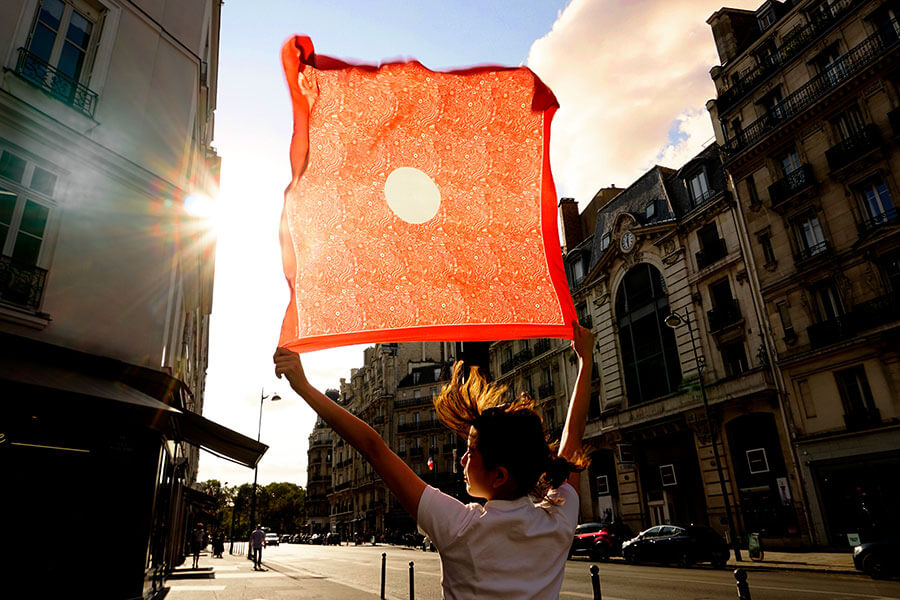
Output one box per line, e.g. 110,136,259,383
725,25,898,158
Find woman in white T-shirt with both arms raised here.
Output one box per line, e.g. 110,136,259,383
274,323,594,599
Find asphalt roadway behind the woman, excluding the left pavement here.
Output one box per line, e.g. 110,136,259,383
264,544,900,600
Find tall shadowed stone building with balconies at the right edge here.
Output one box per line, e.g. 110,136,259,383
708,0,900,548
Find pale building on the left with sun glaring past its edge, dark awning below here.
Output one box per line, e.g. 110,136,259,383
0,0,265,598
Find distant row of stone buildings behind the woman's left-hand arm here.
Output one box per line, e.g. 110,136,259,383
307,342,487,541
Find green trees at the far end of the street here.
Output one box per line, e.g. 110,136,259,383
200,479,306,540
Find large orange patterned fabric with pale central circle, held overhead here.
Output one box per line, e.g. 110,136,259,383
279,36,575,351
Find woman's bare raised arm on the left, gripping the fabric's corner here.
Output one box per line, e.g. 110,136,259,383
274,348,425,519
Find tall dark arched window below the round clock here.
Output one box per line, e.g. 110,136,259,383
616,263,681,405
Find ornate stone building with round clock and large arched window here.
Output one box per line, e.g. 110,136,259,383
491,144,808,547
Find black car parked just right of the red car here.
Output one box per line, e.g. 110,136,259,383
622,525,728,568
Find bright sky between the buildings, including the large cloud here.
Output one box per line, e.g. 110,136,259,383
198,0,761,485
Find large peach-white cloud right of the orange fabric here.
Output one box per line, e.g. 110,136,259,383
528,0,759,206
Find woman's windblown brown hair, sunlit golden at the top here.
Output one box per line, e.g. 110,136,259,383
434,361,587,498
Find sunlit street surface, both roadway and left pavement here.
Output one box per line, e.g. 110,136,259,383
163,544,900,600
